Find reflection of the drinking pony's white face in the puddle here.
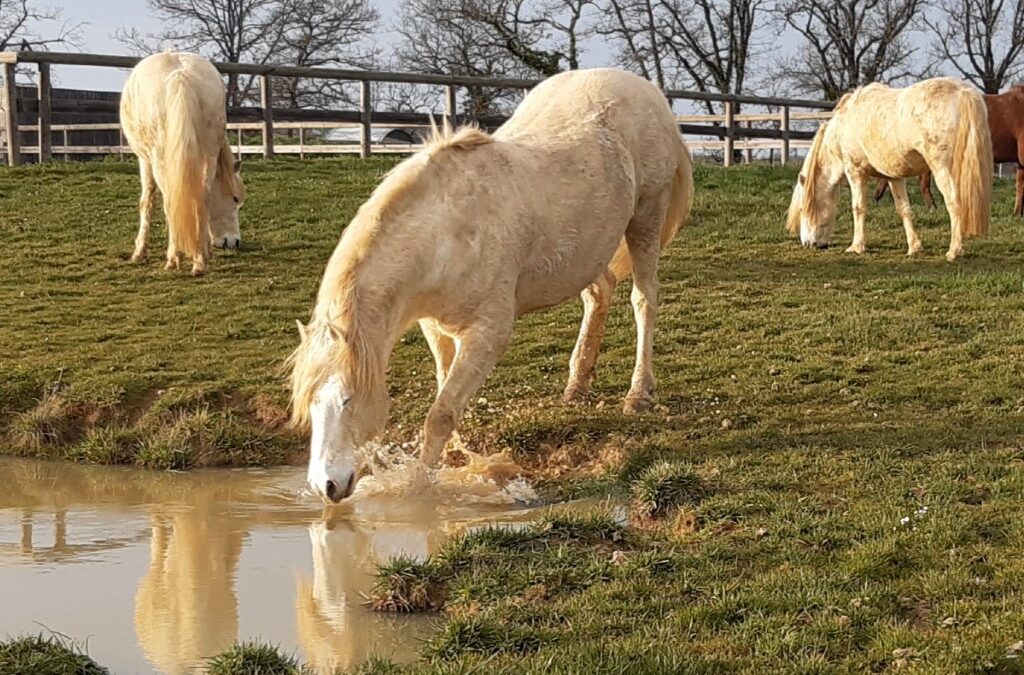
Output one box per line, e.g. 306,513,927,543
295,519,447,673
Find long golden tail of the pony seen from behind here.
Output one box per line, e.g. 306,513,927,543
162,71,209,258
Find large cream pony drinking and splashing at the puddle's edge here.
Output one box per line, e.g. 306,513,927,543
292,69,693,502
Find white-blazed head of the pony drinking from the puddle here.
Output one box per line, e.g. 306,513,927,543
292,324,388,503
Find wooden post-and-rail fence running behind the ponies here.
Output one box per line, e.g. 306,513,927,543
0,51,834,166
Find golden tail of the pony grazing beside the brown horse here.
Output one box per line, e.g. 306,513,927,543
952,90,992,237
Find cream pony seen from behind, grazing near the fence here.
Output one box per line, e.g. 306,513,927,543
121,52,246,275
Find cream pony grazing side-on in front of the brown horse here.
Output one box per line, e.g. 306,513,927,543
787,78,992,260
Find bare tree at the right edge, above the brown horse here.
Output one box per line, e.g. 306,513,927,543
923,0,1024,94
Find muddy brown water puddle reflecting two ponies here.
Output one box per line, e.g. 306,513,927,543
0,460,552,673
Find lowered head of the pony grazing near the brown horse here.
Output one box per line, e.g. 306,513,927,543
786,125,842,249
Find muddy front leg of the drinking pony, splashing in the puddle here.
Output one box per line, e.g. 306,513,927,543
420,310,514,466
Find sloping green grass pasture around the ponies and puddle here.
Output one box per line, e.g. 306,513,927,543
0,159,1024,673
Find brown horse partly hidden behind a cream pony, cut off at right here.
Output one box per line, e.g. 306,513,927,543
874,86,1024,216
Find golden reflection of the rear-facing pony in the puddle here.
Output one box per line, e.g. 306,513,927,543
135,496,246,675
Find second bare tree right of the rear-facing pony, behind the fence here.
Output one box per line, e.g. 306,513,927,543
274,0,380,108
